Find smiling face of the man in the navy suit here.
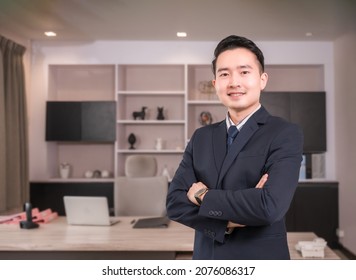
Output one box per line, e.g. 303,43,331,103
213,48,268,122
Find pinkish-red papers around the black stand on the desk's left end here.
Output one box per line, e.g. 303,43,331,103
0,208,58,224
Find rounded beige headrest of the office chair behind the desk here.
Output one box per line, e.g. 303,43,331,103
125,155,157,177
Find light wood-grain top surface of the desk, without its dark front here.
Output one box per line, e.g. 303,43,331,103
0,217,339,259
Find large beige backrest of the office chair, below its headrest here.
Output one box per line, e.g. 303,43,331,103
114,176,168,216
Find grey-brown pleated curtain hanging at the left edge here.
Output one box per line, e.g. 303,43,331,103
0,35,29,211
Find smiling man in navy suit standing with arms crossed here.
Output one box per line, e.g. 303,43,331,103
167,35,303,259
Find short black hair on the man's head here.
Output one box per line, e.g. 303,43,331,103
212,35,265,76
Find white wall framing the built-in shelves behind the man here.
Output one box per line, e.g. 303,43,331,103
29,41,336,180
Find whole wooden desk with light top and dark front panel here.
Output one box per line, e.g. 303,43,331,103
0,217,338,259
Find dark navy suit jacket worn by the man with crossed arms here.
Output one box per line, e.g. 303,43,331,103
167,106,303,259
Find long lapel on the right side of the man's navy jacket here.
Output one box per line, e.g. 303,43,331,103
217,107,269,188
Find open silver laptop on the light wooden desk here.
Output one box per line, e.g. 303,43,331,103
63,196,119,226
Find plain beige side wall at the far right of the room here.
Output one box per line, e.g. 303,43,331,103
335,33,356,254
